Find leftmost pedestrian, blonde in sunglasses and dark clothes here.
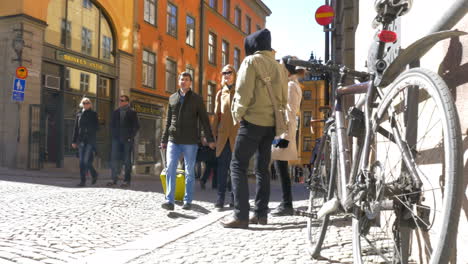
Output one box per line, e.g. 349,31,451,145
72,97,99,187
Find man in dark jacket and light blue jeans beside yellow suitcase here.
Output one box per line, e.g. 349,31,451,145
161,72,215,211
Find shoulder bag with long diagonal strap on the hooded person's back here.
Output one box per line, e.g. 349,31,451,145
253,59,289,137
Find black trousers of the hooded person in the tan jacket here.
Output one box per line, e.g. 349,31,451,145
231,120,275,220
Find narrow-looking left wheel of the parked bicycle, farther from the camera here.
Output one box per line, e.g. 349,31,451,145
307,128,337,258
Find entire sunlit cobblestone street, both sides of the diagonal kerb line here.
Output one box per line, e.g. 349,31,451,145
0,170,352,264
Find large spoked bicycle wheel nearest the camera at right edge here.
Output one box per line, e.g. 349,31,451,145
353,68,463,264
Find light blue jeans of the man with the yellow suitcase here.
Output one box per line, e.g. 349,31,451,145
166,141,198,203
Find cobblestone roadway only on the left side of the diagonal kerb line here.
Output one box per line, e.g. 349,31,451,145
0,175,225,264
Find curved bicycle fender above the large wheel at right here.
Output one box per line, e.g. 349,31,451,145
379,30,468,87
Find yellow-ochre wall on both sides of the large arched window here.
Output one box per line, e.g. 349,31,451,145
0,0,134,53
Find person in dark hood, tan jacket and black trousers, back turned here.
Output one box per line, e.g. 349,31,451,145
221,28,288,228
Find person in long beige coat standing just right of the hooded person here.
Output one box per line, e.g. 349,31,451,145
271,56,305,216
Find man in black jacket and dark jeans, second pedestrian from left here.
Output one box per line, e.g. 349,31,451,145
107,95,140,187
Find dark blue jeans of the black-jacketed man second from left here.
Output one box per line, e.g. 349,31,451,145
111,139,133,183
